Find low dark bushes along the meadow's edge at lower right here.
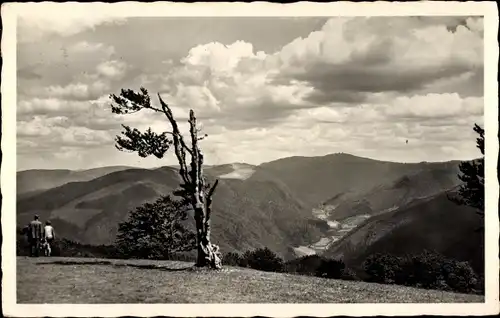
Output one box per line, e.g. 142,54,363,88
364,251,484,293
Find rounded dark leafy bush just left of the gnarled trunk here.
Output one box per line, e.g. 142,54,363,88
116,196,196,259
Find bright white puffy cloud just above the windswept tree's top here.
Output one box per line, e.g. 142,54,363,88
158,41,313,122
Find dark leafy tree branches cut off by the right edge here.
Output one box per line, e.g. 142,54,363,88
450,124,484,217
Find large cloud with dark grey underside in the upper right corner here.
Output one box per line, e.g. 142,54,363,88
277,17,483,103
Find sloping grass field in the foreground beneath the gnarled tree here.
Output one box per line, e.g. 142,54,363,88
17,257,484,304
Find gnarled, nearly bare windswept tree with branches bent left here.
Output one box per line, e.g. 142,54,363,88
110,87,222,269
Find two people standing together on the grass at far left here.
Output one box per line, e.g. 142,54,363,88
27,215,56,257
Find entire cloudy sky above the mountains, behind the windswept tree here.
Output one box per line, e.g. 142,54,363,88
17,14,484,170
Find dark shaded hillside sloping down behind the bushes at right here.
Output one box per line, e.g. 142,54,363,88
324,188,484,273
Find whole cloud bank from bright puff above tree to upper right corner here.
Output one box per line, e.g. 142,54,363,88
150,17,483,128
